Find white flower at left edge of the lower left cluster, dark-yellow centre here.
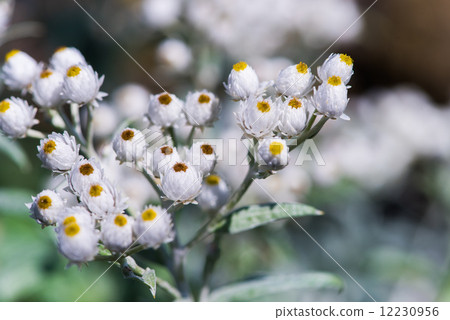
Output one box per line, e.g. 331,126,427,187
27,190,64,227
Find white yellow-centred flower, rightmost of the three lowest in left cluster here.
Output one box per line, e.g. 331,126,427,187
133,206,175,249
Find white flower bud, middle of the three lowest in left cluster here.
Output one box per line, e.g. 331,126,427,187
101,213,134,252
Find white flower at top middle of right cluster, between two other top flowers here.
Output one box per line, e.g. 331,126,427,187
275,62,314,97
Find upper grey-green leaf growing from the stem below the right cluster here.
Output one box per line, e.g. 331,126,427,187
209,203,323,234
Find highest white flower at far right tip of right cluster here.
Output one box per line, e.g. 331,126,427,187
317,53,353,84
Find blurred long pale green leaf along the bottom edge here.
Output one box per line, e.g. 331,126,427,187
208,272,343,301
